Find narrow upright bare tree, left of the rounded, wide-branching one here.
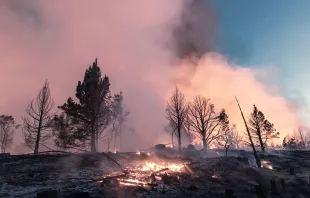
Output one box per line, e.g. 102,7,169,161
166,88,188,151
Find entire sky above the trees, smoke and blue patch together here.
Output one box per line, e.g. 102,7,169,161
0,0,310,152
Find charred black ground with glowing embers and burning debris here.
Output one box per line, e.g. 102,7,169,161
0,149,310,198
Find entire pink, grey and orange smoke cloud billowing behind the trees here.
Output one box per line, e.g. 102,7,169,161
0,0,299,152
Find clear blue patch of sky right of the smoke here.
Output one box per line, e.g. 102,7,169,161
212,0,310,122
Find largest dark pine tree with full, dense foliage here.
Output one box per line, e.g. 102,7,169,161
59,59,111,152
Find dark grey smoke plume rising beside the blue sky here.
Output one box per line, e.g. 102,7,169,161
170,0,216,59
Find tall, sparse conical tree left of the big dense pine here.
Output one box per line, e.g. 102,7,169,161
22,80,54,154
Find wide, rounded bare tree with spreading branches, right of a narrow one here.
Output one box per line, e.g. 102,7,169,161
188,96,228,149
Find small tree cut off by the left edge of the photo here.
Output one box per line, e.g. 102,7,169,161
0,115,20,153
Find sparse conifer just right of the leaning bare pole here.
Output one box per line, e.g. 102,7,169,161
248,105,280,152
